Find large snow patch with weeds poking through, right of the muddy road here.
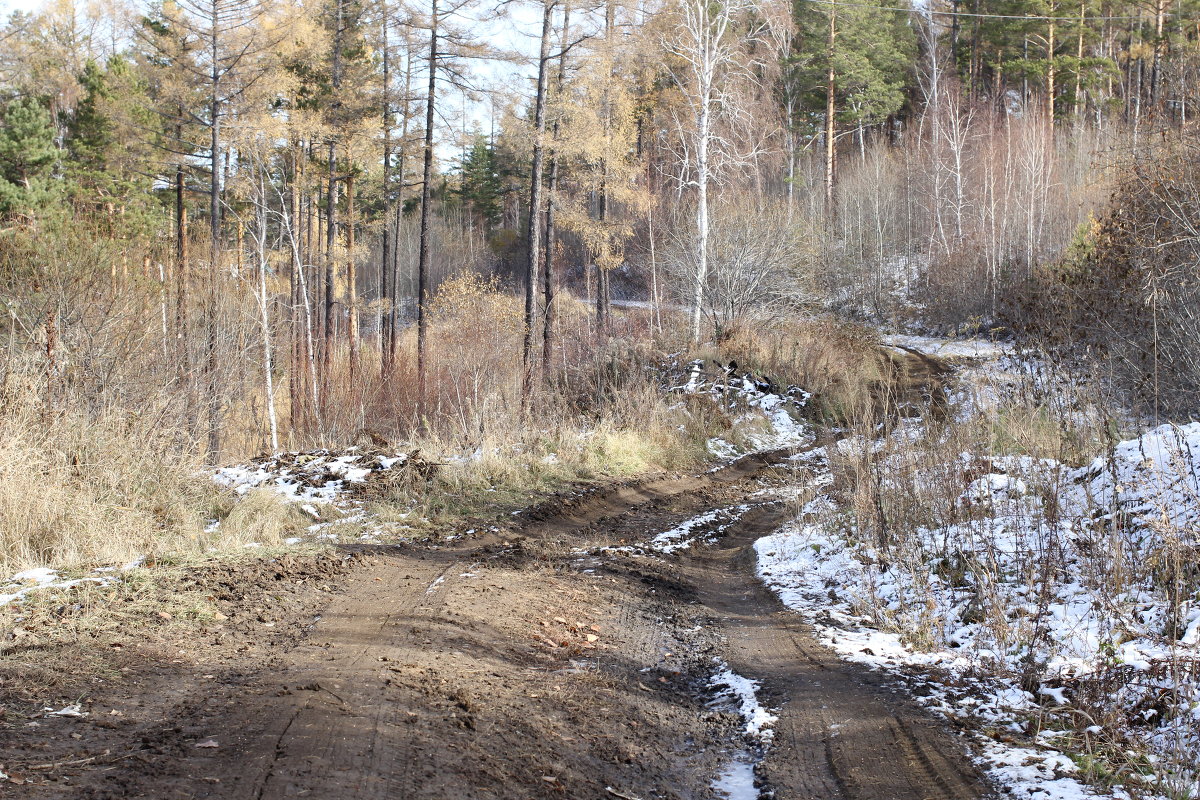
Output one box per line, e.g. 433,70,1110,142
756,423,1200,799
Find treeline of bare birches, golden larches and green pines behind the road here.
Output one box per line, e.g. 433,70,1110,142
0,0,1200,458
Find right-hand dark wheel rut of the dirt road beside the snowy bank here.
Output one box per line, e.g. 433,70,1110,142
682,494,988,800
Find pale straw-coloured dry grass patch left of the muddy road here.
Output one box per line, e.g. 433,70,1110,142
0,374,314,573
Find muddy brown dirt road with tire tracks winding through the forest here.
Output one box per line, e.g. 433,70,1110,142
0,453,985,800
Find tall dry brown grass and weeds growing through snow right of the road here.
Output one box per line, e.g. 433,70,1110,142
811,355,1200,796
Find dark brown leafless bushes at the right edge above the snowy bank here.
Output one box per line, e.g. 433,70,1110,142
1012,134,1200,419
